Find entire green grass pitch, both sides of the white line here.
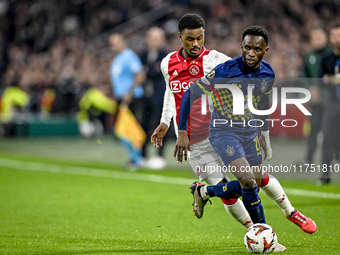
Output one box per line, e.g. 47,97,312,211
0,135,340,255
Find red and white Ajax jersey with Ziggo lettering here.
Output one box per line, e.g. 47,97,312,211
161,47,230,144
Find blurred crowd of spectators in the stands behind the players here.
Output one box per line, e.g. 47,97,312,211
0,0,340,133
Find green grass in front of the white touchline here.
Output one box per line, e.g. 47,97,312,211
0,161,340,254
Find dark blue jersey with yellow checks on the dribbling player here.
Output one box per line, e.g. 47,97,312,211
179,56,275,132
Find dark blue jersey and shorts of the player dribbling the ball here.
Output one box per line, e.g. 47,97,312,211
178,56,275,166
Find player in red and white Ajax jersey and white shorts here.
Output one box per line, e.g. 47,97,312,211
151,14,253,227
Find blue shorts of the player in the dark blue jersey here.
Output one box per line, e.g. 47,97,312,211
209,130,262,166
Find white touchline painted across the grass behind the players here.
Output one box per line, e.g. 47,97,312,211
0,158,340,200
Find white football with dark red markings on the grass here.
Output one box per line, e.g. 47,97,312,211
244,223,277,254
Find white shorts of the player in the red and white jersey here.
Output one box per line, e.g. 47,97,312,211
188,138,229,185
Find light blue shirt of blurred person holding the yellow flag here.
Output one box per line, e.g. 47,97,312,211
110,49,144,99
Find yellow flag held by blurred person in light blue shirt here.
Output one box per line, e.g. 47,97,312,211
114,103,146,149
